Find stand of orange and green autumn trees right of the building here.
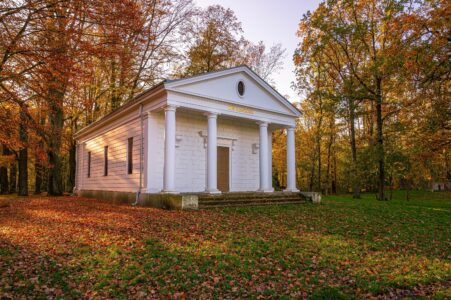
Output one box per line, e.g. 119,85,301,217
294,0,449,200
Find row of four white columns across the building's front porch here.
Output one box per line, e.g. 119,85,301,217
155,99,298,194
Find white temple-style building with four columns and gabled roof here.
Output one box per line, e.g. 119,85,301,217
75,66,300,206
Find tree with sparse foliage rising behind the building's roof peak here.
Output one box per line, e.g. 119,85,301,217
181,5,285,83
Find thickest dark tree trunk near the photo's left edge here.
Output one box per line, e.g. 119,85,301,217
18,107,28,196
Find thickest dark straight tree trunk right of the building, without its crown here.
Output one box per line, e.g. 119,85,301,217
376,78,386,201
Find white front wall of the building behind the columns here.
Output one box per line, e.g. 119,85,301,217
147,110,259,193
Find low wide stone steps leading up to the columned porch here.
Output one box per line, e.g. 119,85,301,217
198,192,312,209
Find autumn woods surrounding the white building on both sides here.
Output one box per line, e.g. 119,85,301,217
0,0,451,200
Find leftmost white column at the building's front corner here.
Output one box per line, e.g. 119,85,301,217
162,105,176,193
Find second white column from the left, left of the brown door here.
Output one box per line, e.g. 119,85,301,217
205,113,220,194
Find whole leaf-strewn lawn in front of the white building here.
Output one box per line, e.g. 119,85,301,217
0,192,451,299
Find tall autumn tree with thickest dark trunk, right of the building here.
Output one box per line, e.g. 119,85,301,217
296,0,420,200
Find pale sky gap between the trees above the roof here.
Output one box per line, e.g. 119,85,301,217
195,0,320,102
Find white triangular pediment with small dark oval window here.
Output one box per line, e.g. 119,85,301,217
165,66,300,117
